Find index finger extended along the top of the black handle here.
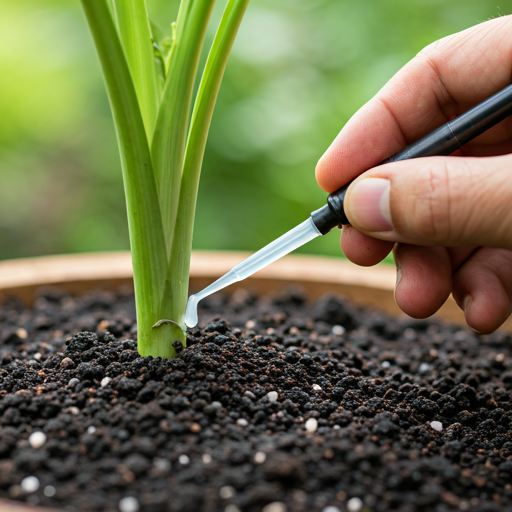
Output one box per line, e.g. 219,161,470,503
316,16,512,192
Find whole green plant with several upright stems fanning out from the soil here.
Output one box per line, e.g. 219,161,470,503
80,0,249,357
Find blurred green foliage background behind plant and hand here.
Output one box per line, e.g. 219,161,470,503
0,0,506,259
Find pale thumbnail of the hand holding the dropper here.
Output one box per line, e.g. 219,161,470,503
348,178,393,231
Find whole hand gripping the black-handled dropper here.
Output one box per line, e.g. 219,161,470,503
316,16,512,333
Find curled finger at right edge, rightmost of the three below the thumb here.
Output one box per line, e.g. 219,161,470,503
453,248,512,333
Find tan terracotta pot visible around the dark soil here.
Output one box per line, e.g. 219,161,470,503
0,251,512,512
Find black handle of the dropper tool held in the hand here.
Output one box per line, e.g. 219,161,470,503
311,85,512,235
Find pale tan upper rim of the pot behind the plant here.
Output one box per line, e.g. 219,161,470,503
0,251,395,293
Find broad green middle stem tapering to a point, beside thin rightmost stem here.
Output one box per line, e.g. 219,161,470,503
151,0,215,255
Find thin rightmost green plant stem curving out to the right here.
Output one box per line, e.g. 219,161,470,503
169,0,249,321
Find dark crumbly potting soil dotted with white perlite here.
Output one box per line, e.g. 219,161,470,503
0,284,512,512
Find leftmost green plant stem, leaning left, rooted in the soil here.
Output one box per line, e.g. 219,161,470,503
81,0,176,357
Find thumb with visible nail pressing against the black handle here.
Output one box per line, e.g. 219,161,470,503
345,155,512,249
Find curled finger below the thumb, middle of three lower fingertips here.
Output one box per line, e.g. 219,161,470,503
394,244,452,318
